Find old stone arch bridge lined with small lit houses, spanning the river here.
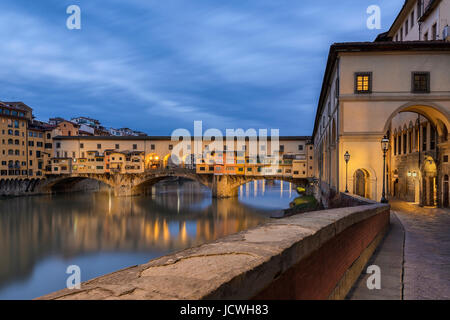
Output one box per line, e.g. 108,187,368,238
0,136,314,198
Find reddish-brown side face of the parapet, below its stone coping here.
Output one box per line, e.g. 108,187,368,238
254,209,389,300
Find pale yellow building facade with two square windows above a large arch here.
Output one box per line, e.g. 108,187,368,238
313,41,450,206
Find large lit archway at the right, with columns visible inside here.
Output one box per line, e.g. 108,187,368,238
385,103,450,207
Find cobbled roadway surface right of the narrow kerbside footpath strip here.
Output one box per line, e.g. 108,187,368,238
390,200,450,300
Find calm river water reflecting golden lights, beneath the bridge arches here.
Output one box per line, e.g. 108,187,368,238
0,181,297,299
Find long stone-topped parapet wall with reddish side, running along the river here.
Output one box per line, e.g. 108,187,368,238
40,195,390,300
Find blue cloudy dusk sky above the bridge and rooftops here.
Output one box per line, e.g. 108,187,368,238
0,0,403,135
